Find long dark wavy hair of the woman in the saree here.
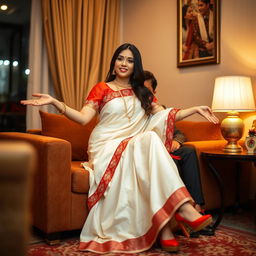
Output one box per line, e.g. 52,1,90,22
105,43,153,115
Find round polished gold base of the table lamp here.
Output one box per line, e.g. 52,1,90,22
220,111,244,154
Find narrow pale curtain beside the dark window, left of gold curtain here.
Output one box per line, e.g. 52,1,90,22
26,0,54,129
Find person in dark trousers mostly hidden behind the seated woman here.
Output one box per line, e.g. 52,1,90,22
144,71,214,237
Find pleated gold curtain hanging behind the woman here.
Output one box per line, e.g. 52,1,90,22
42,0,120,110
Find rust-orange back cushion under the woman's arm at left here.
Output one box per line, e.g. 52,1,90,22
39,111,97,161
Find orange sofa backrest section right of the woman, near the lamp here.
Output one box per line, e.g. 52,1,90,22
176,120,223,141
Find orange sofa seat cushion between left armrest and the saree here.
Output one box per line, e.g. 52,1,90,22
71,161,89,193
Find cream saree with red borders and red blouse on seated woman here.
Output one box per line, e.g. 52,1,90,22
79,82,192,253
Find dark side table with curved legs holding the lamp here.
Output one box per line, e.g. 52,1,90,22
201,150,256,229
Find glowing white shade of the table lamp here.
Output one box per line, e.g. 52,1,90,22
212,76,255,112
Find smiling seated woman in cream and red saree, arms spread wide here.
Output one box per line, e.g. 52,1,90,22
21,44,218,253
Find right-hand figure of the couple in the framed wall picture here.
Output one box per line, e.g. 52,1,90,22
193,0,214,57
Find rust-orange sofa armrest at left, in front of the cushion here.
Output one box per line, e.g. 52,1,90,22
0,132,71,233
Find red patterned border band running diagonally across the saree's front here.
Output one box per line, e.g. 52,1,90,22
87,137,132,210
